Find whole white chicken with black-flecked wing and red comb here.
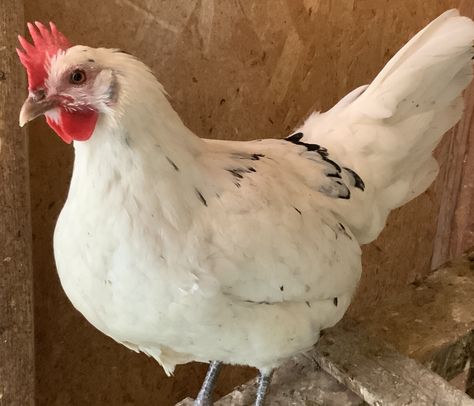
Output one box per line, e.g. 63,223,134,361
17,10,474,405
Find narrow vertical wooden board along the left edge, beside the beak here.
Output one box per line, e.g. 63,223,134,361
0,0,34,406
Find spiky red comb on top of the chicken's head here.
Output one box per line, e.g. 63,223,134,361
16,22,71,90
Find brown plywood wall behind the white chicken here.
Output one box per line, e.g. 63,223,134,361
26,0,466,406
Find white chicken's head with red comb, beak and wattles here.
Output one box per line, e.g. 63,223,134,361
17,22,117,143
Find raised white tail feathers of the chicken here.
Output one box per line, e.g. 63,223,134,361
299,10,474,242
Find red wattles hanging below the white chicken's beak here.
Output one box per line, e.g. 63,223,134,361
46,109,99,144
